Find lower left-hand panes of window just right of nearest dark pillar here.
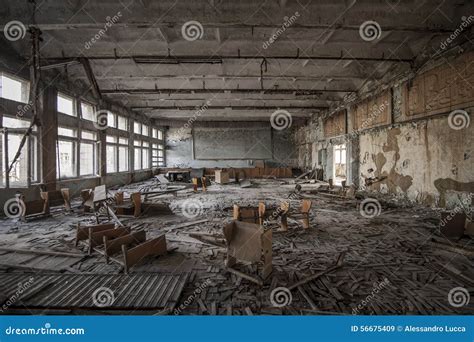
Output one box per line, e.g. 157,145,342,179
56,127,77,179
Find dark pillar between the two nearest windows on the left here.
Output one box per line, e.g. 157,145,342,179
38,86,58,191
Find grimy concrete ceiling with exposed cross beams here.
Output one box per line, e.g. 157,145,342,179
0,0,473,120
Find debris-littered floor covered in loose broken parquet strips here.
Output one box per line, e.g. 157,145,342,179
0,179,474,315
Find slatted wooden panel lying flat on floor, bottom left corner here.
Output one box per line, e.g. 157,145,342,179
0,273,188,313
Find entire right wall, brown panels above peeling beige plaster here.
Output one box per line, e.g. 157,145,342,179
296,52,474,208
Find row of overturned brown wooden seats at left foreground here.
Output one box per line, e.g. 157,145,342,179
75,223,167,273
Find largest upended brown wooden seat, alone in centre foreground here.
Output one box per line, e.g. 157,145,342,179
224,221,272,285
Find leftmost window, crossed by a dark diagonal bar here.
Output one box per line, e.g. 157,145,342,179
0,116,38,187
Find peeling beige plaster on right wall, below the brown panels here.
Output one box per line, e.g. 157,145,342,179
360,117,474,207
